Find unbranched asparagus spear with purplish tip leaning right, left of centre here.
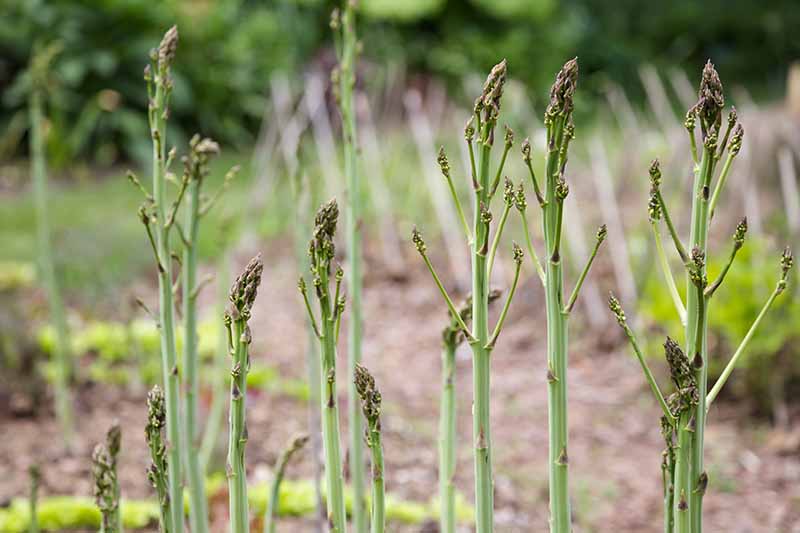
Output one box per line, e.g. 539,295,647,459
225,254,264,533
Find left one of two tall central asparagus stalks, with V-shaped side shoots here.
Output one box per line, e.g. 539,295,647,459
412,61,523,533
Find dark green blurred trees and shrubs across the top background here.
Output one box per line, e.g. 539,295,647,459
0,0,800,162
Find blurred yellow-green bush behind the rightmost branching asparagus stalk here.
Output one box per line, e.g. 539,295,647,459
641,239,800,414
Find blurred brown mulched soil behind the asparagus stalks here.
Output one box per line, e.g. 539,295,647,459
0,239,800,533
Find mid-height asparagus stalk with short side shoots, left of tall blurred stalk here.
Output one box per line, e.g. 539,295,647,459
298,200,346,533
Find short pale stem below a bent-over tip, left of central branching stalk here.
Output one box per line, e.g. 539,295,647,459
439,342,456,533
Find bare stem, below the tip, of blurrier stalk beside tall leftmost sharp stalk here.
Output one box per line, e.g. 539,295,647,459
182,179,208,533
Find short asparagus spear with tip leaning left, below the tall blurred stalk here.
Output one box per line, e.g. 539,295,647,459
353,364,386,533
